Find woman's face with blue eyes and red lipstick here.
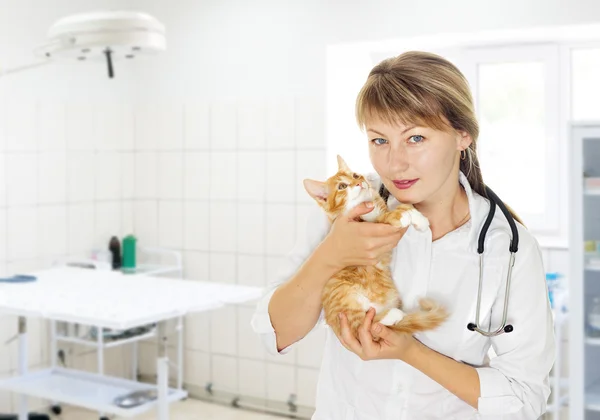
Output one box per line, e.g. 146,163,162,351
366,119,471,204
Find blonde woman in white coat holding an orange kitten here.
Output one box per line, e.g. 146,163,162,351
252,52,555,420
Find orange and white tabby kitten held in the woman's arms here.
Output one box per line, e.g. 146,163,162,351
304,156,447,336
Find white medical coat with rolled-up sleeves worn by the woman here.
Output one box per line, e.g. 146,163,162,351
251,173,555,420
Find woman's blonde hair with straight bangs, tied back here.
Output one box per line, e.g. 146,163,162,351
356,51,522,223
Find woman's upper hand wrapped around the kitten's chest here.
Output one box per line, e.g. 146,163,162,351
323,203,406,270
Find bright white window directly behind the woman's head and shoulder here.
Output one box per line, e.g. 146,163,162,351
458,45,561,235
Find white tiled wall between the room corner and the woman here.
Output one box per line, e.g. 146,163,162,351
134,97,326,405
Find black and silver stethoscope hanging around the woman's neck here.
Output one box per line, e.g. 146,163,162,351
379,184,519,337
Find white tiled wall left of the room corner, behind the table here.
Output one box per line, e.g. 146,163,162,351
0,97,135,413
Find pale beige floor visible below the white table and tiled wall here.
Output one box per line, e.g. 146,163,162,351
57,399,284,420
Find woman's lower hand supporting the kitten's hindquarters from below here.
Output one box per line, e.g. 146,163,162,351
338,308,417,360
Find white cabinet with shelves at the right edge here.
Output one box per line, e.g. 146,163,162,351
568,121,600,420
